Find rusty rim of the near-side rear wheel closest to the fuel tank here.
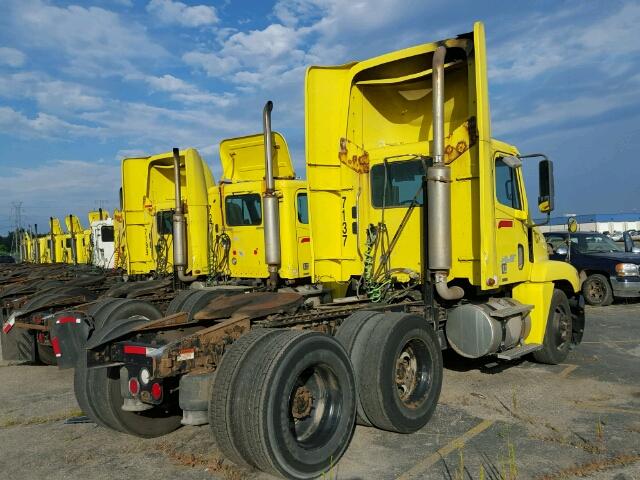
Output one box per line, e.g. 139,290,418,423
395,338,431,409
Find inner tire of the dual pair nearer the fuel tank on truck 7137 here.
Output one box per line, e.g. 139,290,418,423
335,310,379,427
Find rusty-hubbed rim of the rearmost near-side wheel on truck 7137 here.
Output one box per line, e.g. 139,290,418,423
289,364,342,448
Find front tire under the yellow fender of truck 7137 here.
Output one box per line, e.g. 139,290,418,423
533,290,572,365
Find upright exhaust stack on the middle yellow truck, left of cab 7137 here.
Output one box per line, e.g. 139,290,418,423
262,100,282,289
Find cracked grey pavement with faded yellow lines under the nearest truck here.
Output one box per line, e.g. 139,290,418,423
0,304,640,480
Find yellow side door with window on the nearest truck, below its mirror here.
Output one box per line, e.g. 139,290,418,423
494,152,530,284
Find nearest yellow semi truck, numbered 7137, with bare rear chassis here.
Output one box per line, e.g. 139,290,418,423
70,23,584,479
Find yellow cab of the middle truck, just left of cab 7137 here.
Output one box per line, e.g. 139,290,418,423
219,132,311,282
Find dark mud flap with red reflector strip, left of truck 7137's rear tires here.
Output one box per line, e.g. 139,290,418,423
49,311,93,369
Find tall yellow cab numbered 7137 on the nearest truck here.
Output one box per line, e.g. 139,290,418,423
305,23,583,358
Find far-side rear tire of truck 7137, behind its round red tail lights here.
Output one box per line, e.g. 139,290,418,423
74,299,181,438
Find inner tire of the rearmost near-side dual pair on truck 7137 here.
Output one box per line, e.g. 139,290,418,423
209,328,276,466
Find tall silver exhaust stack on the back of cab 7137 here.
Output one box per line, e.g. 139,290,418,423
427,46,464,300
